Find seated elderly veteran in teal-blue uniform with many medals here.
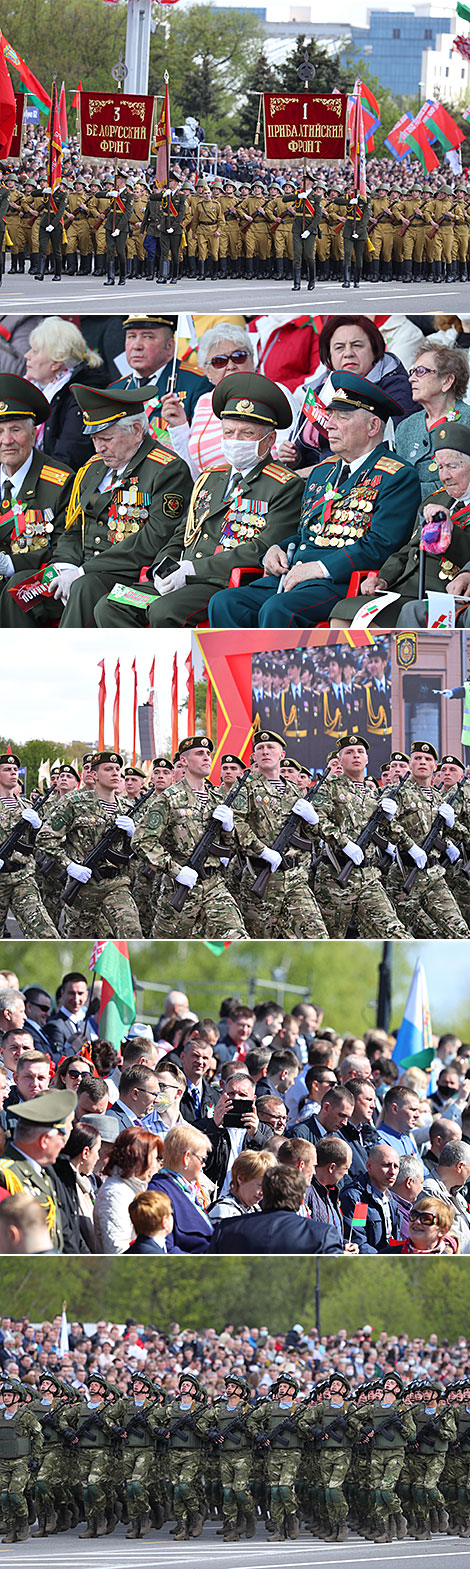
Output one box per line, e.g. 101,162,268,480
208,372,420,628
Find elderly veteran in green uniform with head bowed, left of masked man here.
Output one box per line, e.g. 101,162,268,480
0,378,191,626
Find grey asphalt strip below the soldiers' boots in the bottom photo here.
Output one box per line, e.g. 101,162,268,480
0,1525,468,1569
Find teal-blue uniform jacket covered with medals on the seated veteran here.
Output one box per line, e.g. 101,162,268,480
280,442,421,585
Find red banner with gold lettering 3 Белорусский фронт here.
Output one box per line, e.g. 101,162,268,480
78,93,155,166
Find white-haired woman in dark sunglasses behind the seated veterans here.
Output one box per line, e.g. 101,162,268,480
161,322,301,480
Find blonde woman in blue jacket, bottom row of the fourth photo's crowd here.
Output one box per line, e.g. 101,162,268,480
149,1122,213,1254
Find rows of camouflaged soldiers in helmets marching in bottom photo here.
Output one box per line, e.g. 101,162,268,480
0,1367,470,1544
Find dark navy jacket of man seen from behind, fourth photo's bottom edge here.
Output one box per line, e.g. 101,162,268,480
210,1210,343,1254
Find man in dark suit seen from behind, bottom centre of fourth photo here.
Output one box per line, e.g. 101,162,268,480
208,1166,343,1254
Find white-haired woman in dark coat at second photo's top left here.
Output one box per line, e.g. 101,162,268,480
25,315,110,471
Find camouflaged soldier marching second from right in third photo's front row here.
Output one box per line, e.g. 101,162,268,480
315,736,407,938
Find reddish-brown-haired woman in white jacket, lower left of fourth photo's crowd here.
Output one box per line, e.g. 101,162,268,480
94,1123,163,1254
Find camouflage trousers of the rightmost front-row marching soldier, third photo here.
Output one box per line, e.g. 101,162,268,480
384,866,470,937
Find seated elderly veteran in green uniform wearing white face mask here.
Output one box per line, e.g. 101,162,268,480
96,372,304,626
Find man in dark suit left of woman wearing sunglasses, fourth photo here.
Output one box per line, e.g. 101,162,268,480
342,1144,400,1254
